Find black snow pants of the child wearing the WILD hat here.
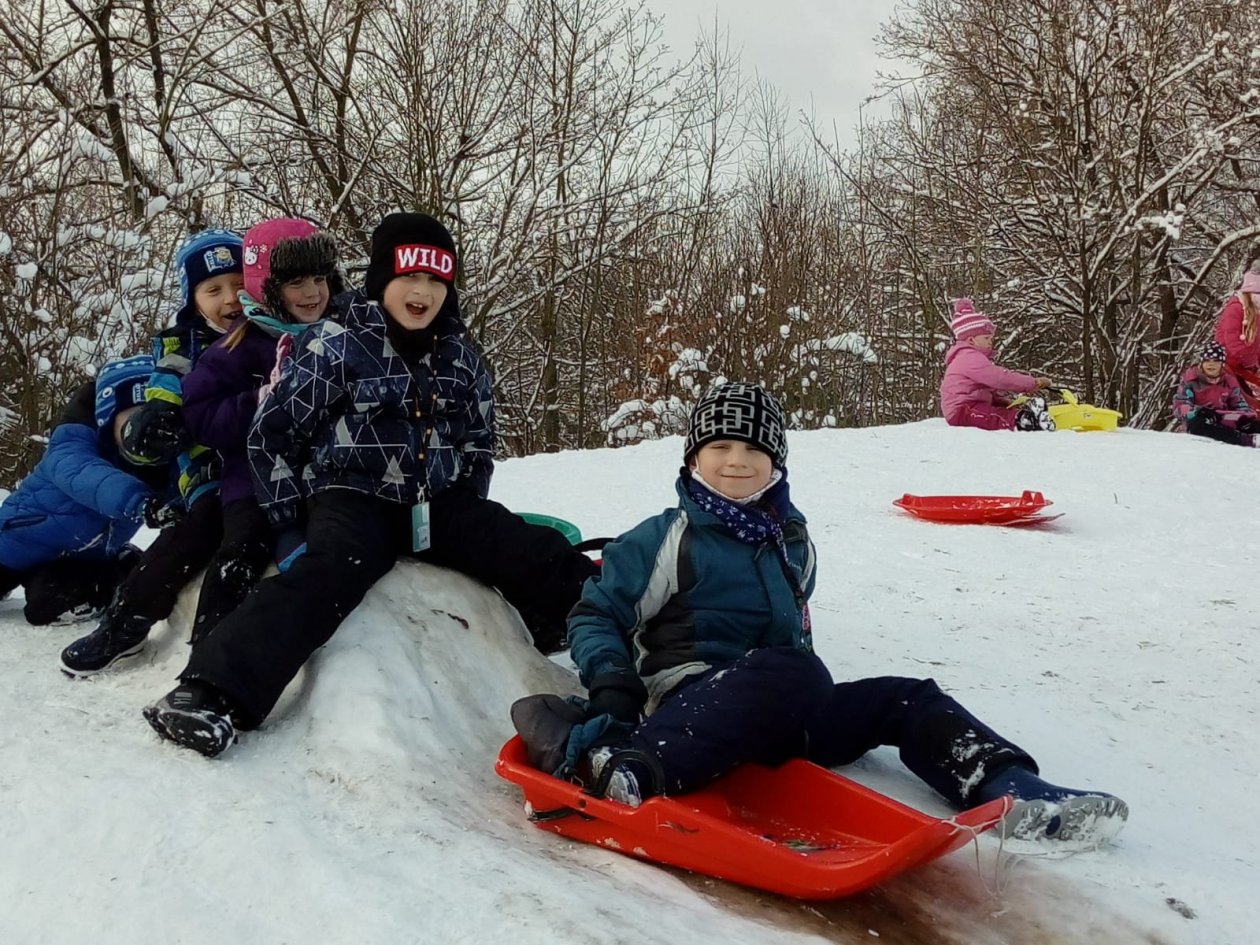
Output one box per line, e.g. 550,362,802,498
180,488,596,728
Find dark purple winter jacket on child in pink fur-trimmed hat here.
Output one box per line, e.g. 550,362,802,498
184,324,276,504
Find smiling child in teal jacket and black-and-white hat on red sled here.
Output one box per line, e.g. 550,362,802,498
513,384,1128,845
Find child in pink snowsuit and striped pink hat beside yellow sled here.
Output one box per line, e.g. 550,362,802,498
941,299,1055,430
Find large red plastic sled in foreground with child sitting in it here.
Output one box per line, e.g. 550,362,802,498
495,736,1011,900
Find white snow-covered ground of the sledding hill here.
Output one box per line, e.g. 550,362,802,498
0,421,1260,945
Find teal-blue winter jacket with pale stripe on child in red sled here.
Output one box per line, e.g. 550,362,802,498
568,479,814,713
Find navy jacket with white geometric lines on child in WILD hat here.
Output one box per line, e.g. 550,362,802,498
249,291,494,528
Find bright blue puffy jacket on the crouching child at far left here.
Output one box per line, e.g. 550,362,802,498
0,383,166,571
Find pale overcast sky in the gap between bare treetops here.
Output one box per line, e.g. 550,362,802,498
648,0,893,141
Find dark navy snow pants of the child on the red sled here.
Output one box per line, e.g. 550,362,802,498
630,646,1037,808
